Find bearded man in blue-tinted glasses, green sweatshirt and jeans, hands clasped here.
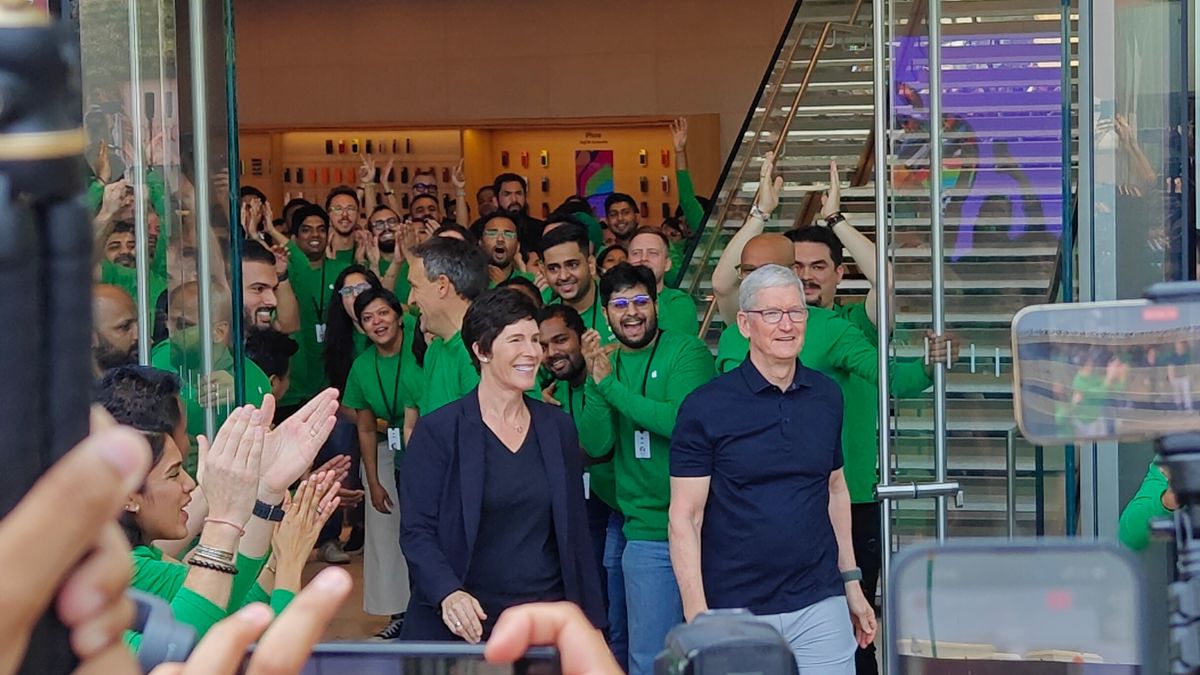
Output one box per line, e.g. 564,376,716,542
578,261,713,675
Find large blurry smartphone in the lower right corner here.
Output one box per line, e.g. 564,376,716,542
884,539,1146,675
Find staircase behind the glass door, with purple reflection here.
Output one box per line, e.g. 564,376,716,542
680,0,1078,542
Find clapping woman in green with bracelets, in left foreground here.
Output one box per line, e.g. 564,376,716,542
121,408,338,651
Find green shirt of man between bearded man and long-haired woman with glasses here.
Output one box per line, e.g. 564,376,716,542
280,239,353,406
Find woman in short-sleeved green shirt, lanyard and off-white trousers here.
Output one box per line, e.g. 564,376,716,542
342,283,421,619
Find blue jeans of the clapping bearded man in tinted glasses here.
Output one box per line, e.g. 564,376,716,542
622,542,683,675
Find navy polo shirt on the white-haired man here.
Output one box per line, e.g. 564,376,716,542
671,359,845,614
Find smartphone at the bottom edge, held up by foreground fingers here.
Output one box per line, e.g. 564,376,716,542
241,643,563,675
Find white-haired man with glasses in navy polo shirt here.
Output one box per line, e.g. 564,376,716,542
670,264,876,675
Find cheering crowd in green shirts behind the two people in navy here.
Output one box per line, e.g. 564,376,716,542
88,121,984,673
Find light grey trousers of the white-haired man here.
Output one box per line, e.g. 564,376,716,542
756,596,858,675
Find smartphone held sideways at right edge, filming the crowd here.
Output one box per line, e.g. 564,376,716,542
1013,290,1200,444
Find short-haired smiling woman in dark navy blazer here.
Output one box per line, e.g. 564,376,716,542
400,288,604,643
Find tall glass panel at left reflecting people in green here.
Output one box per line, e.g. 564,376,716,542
72,0,242,466
